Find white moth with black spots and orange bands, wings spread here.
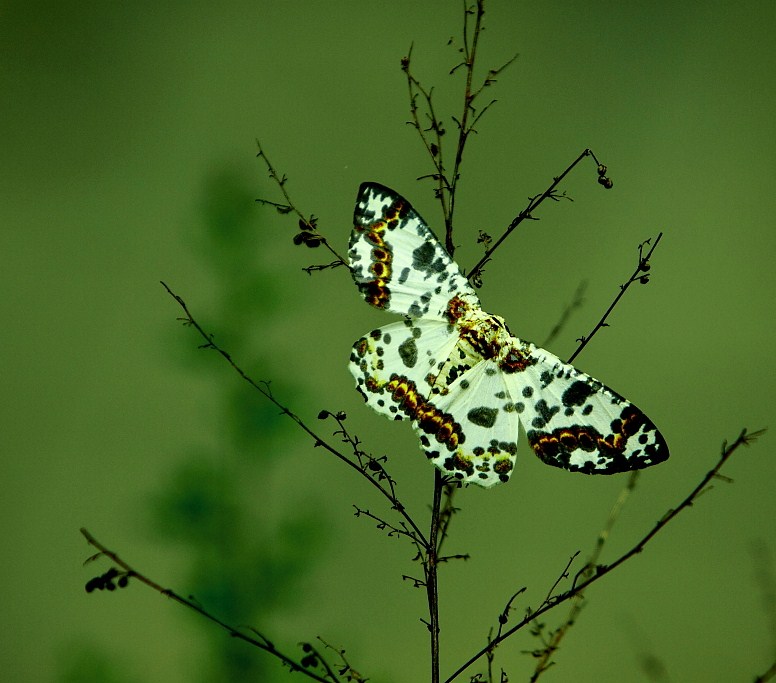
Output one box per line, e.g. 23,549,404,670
348,182,668,487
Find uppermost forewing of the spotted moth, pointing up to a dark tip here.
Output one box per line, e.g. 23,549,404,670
348,183,477,320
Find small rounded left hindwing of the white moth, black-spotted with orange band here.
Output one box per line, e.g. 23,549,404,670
350,318,458,420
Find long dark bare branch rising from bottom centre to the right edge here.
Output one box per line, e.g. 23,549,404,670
444,429,765,683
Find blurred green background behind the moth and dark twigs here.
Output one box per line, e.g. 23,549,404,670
0,0,776,683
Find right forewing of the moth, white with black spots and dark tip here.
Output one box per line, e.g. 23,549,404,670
505,339,668,474
